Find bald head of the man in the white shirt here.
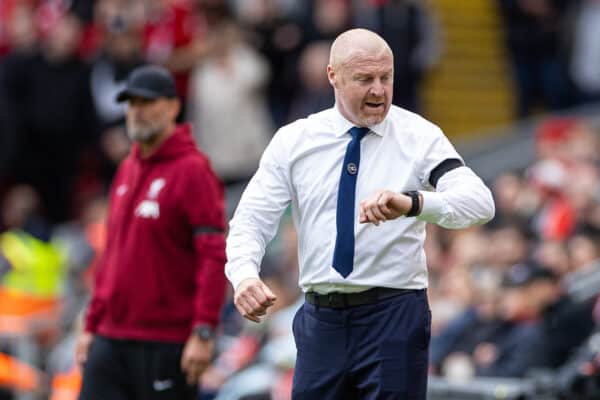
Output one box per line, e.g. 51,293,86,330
327,29,394,127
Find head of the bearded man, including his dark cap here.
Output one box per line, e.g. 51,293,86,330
117,65,181,145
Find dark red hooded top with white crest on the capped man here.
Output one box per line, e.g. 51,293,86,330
86,125,226,342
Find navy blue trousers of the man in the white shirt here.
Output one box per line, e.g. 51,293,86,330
292,290,431,400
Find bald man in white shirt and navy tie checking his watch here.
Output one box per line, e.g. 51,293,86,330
226,29,494,400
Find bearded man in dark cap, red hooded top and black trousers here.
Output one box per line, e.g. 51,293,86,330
77,66,225,400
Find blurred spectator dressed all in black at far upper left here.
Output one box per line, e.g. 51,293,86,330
0,13,96,222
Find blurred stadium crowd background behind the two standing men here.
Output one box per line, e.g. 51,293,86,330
0,0,600,400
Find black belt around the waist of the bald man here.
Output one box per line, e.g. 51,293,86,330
304,287,420,309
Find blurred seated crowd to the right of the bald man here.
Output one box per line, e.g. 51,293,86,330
427,117,600,399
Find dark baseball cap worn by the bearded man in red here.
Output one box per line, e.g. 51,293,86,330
117,65,177,103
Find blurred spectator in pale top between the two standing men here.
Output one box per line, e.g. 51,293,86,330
189,21,272,215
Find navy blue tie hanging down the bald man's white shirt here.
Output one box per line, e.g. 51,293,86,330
333,126,369,278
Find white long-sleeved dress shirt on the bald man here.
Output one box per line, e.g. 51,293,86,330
225,106,494,293
